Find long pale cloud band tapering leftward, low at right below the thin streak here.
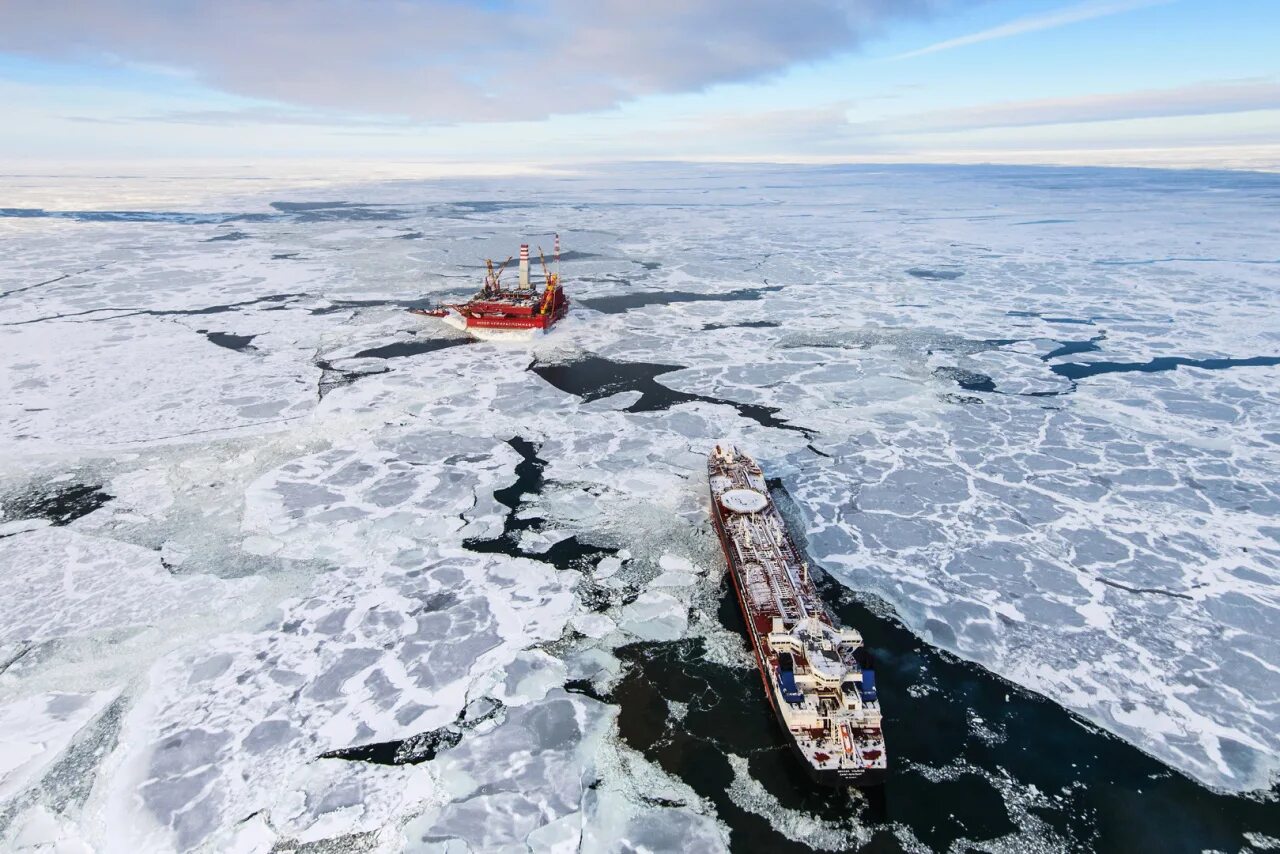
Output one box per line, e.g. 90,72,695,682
849,78,1280,136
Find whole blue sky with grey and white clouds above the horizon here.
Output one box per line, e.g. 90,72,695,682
0,0,1280,169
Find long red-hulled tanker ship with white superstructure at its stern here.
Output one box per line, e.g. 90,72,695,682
707,446,887,786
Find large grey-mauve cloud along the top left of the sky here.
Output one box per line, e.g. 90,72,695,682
0,0,969,122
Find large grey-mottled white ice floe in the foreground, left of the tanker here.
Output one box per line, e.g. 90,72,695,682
60,429,721,850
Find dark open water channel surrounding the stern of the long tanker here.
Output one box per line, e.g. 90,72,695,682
599,478,1280,854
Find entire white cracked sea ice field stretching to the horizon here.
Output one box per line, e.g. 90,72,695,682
0,166,1280,851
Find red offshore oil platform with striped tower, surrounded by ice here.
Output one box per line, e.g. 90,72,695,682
411,240,568,335
